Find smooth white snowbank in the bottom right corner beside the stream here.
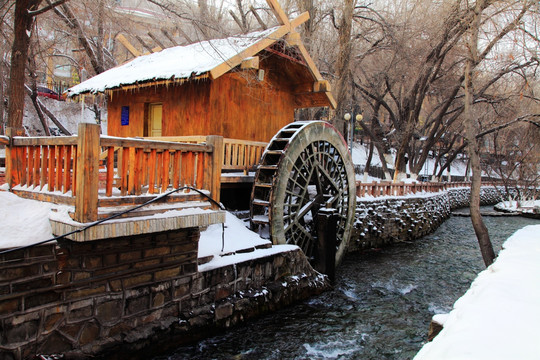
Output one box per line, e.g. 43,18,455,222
414,225,540,360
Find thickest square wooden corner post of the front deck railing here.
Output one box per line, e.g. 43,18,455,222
75,123,100,223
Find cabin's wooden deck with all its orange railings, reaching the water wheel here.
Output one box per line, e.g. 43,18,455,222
0,124,266,223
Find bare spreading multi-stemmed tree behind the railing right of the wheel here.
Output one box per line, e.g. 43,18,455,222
346,0,538,180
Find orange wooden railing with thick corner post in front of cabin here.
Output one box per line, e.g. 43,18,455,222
6,124,223,222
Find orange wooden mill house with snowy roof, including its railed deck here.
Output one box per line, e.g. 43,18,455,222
6,0,335,222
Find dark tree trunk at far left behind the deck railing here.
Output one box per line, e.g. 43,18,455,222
8,0,41,131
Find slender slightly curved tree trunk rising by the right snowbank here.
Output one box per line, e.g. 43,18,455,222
465,0,495,267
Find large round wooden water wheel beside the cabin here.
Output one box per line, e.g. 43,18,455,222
251,121,356,264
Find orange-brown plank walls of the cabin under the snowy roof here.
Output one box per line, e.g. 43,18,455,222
108,59,294,142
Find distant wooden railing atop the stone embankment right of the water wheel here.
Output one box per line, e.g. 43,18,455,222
356,182,474,197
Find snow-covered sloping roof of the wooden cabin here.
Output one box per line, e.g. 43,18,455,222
67,26,283,96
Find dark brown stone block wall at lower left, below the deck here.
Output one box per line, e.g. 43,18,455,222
0,228,329,360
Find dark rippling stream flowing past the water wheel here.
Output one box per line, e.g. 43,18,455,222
154,210,538,360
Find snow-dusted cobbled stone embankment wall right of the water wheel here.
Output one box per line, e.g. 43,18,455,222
349,187,500,251
